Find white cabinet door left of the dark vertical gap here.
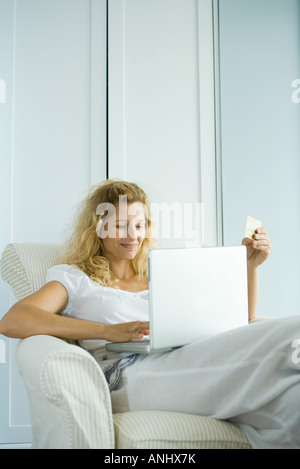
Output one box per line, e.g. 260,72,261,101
0,0,106,447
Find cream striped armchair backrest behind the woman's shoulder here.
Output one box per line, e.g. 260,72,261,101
1,243,60,300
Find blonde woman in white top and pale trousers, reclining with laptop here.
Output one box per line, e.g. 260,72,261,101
0,181,300,448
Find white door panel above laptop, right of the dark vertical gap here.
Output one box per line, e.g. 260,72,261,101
108,0,217,245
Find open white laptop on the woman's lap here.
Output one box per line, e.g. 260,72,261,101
106,246,248,354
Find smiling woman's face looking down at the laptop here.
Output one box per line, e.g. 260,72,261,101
101,202,146,260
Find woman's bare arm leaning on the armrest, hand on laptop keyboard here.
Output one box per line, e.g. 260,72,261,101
0,282,149,342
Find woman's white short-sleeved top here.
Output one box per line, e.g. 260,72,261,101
46,264,149,350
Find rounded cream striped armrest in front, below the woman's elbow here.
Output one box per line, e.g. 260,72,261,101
16,336,114,449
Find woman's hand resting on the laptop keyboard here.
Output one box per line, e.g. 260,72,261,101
103,321,150,342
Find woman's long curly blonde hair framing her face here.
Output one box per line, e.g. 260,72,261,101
60,179,157,287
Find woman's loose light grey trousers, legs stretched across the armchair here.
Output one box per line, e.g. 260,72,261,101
99,315,300,449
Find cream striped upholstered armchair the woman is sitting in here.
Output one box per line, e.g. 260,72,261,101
1,243,251,449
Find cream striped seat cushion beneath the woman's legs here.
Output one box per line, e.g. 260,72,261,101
114,411,251,449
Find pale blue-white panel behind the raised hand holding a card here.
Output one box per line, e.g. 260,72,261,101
220,0,300,316
